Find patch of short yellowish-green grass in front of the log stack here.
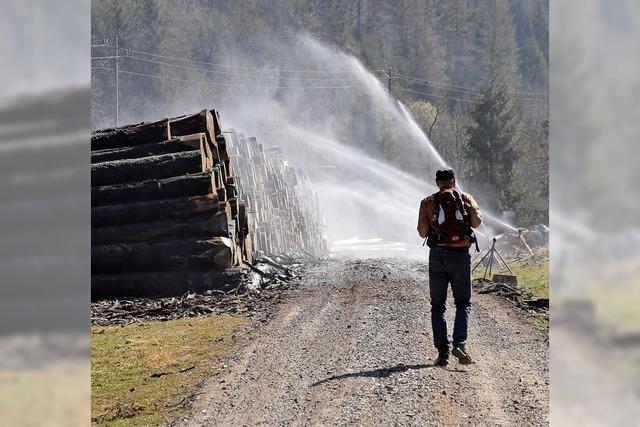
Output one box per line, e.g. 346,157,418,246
91,315,247,427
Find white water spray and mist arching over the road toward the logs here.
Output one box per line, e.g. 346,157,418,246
134,34,528,258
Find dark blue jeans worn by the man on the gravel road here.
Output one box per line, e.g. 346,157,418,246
429,248,471,350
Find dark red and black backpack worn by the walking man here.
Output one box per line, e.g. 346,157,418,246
427,188,479,252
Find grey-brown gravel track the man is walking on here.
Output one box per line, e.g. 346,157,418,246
186,259,549,426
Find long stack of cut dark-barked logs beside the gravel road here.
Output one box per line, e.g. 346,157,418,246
91,110,326,299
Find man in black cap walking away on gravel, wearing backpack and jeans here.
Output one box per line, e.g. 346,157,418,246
418,169,482,366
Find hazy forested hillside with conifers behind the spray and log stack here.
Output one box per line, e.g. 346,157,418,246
92,0,549,224
